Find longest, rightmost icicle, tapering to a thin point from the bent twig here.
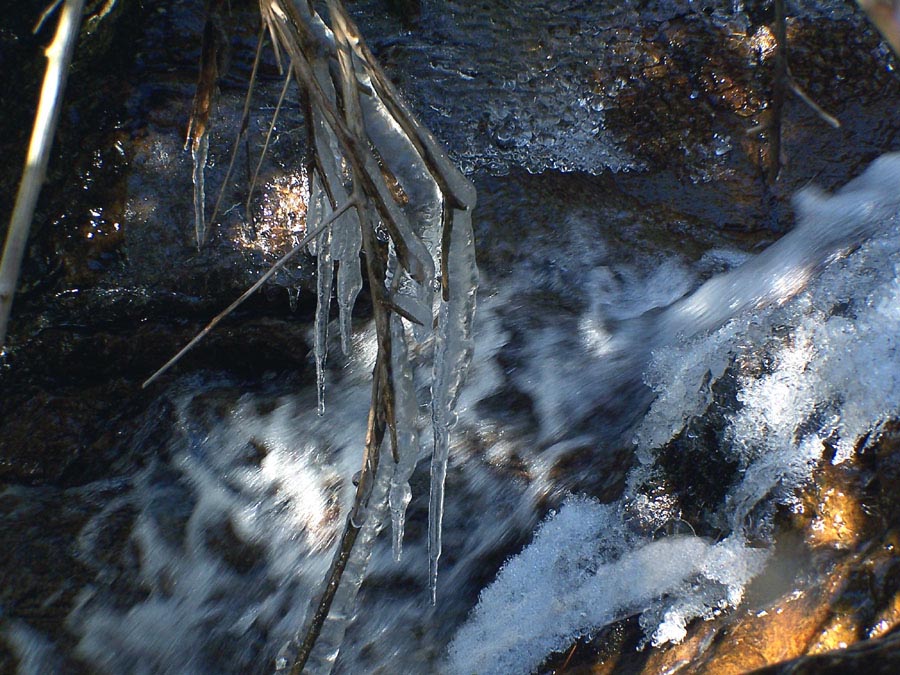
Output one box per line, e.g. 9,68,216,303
428,205,478,603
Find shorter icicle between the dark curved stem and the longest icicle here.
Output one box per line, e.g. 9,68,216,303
389,314,419,562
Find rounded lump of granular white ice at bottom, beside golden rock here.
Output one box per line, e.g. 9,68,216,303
448,499,766,675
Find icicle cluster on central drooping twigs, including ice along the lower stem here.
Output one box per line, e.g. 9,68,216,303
201,0,478,671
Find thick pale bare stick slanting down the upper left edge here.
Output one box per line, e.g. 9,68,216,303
0,0,84,349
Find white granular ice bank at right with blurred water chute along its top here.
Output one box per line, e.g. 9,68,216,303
446,154,900,674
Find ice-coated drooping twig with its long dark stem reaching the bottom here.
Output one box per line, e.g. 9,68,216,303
251,0,477,673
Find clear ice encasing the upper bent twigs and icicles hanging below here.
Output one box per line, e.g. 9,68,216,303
251,3,486,649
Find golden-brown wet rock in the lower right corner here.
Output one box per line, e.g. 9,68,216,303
541,415,900,675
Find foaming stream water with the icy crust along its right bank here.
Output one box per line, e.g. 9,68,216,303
5,155,900,673
